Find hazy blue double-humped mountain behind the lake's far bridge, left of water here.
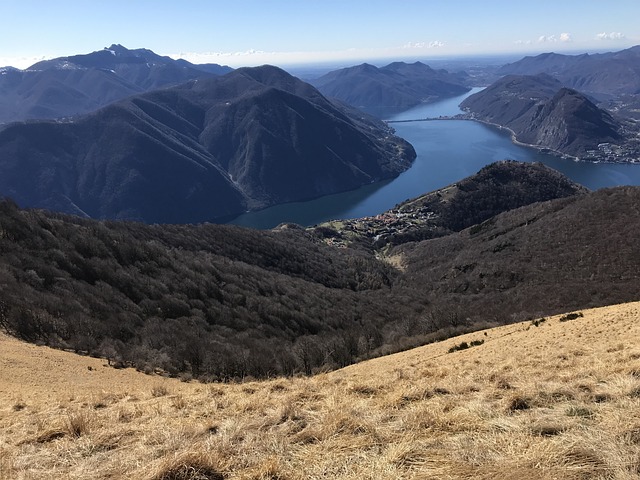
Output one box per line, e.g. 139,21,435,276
312,62,469,113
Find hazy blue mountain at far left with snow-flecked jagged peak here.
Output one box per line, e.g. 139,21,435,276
0,45,231,123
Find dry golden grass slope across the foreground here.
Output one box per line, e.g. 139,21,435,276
0,303,640,480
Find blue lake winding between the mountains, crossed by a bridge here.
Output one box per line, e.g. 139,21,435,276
229,88,640,229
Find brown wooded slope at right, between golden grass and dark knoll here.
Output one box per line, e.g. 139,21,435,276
390,187,640,322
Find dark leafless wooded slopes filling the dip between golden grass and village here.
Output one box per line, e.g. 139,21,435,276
0,164,640,379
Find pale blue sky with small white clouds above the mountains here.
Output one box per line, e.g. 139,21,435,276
0,0,640,68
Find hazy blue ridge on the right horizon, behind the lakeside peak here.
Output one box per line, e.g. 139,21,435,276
498,45,640,96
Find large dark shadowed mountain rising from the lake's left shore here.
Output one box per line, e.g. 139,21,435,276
0,65,415,223
